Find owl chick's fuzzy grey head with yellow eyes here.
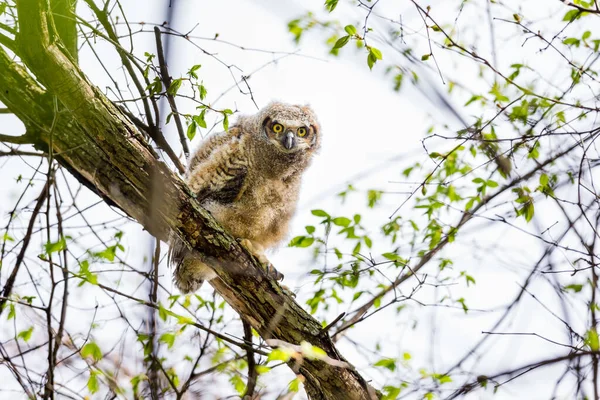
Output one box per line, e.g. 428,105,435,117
259,103,321,154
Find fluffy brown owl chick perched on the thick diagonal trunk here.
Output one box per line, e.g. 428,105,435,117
170,103,321,293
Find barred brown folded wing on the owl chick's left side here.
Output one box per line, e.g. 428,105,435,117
188,128,248,203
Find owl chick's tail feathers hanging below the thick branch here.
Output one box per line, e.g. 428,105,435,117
169,236,216,293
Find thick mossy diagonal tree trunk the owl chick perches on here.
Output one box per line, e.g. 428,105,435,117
0,0,377,399
